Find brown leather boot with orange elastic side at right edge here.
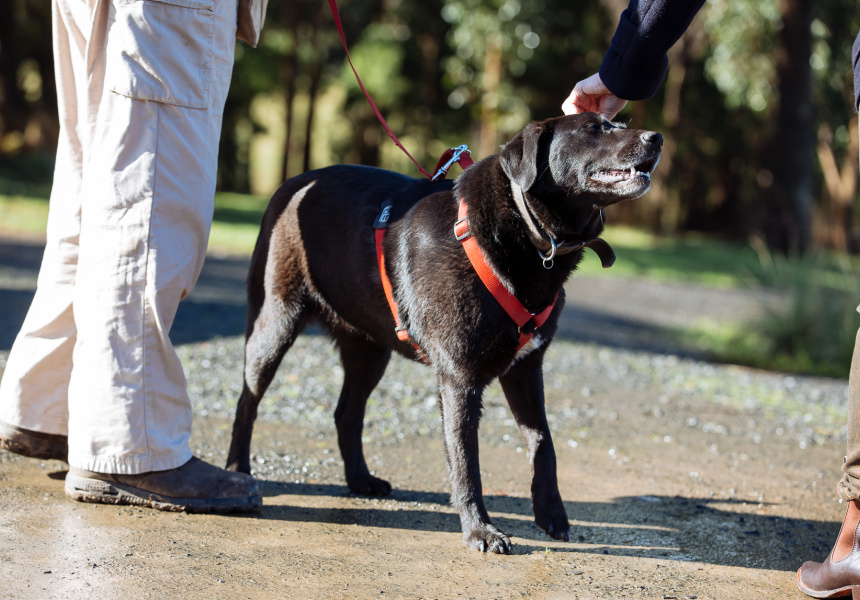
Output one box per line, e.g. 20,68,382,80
797,500,860,600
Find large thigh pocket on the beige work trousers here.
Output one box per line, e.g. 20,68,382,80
105,0,215,108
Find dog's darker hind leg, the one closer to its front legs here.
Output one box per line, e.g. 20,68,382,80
334,333,391,496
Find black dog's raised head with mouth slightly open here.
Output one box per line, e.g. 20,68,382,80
499,113,663,206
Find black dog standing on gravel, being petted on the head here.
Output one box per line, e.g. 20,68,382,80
227,114,663,554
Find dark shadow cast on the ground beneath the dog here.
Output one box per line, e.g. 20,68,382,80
245,481,839,571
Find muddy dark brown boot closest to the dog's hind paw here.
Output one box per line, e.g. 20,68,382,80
66,457,263,513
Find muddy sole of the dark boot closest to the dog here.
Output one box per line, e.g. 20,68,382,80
65,473,263,514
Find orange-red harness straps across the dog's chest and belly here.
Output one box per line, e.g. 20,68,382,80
375,188,558,365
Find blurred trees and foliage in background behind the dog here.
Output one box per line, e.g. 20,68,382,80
0,0,860,258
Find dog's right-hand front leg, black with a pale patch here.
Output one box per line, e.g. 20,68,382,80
499,352,570,541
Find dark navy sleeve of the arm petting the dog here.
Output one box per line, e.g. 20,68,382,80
600,0,704,100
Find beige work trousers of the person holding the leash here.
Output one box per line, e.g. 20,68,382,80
0,0,237,474
